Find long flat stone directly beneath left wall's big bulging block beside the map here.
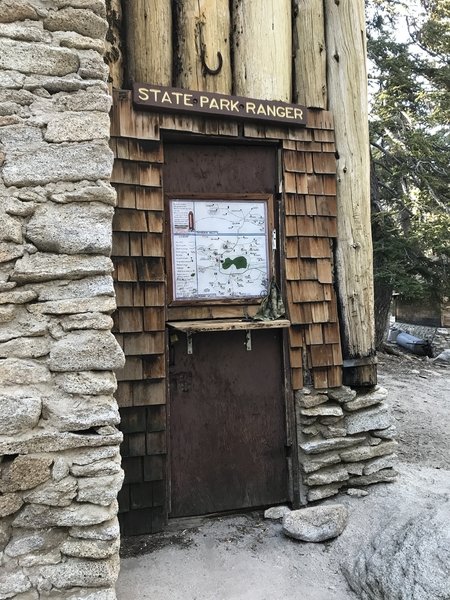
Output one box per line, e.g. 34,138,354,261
11,252,113,283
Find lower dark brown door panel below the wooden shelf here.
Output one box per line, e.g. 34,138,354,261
170,330,287,517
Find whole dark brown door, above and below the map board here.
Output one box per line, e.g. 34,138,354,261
164,142,288,517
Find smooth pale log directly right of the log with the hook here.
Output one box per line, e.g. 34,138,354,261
233,0,292,102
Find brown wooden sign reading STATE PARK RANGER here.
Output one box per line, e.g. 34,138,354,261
133,83,307,127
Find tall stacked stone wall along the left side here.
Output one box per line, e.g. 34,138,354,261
0,0,123,600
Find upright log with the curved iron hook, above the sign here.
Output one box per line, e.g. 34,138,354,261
175,0,231,94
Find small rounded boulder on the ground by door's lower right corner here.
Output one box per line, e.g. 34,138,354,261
283,504,348,542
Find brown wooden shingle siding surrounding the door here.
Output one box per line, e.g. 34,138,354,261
110,90,342,528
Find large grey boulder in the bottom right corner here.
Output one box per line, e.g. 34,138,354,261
344,501,450,600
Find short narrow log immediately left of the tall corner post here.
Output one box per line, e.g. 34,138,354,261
294,0,328,109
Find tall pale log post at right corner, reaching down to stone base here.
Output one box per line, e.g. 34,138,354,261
325,0,376,385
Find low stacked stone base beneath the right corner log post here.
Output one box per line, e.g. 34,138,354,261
295,386,397,502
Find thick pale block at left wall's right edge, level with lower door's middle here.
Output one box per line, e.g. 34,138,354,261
42,392,120,431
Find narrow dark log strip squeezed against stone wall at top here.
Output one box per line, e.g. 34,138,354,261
105,0,123,90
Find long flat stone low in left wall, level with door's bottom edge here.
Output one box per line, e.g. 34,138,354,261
13,502,118,528
